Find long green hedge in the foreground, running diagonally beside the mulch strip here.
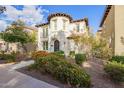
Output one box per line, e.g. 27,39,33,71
29,54,90,87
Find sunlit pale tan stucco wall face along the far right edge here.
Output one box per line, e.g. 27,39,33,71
115,5,124,55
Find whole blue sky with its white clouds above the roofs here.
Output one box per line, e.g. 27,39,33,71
0,5,105,32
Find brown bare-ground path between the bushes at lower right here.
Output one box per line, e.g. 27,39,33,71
83,59,124,88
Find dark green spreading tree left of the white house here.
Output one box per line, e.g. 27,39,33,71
1,20,36,53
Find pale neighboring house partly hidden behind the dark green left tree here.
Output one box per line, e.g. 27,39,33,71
0,26,37,53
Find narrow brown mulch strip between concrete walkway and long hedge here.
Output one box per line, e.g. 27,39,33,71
17,67,69,88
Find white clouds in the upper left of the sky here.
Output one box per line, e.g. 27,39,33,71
0,6,49,30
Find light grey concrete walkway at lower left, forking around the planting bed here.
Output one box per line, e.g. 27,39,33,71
0,61,56,88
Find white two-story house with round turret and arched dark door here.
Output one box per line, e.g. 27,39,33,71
36,13,88,55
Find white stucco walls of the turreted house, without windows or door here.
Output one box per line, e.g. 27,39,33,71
38,16,86,55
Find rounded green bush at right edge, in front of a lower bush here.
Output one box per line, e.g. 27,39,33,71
104,61,124,82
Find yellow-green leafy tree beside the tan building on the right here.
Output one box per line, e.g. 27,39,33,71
92,37,112,60
